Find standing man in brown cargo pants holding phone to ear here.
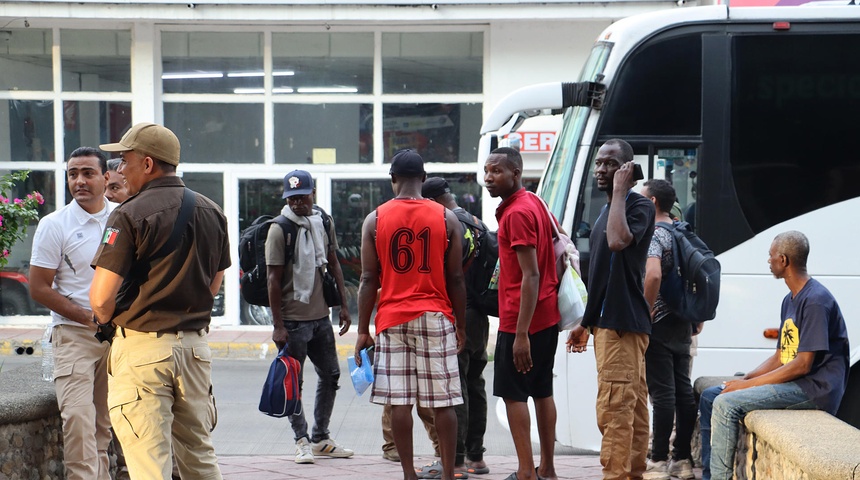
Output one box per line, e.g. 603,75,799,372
567,139,655,480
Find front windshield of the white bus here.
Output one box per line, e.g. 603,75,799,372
538,42,612,219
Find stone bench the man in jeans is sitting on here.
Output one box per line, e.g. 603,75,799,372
694,377,860,480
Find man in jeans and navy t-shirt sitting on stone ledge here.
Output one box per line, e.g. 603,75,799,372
699,231,850,480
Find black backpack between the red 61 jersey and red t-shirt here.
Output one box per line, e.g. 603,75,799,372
458,215,499,317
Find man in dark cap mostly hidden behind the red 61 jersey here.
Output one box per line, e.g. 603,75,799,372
421,177,490,474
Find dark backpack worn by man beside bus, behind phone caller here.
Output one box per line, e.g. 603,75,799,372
657,222,720,323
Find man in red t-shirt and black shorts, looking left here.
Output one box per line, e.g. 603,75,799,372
484,147,560,480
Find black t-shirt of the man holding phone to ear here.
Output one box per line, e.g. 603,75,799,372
582,191,655,334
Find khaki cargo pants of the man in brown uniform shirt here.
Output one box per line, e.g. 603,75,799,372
108,328,221,480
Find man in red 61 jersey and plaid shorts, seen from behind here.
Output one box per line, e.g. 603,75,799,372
355,150,466,480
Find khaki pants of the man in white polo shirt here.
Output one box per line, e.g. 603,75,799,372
51,325,111,480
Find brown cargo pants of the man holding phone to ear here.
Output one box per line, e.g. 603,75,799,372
594,328,649,480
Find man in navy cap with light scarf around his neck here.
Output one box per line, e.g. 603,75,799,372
266,170,354,463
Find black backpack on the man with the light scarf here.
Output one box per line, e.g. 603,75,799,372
239,205,331,307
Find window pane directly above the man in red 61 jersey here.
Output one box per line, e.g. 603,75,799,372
382,103,482,163
